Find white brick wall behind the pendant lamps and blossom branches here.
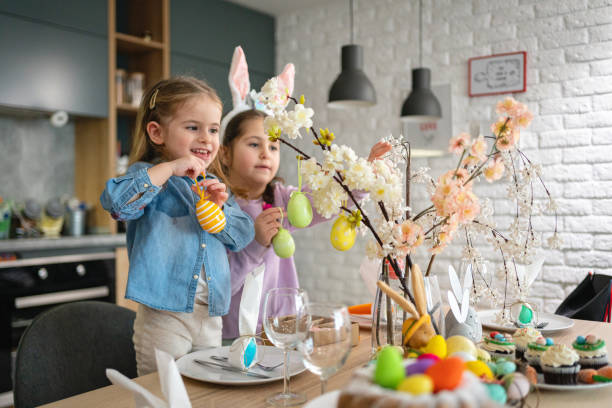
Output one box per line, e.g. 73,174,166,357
276,0,612,311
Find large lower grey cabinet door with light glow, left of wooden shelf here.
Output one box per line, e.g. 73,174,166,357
0,9,108,117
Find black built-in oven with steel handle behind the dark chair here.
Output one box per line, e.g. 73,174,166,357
0,251,115,393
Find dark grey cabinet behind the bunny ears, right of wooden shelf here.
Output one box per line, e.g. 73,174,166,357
170,0,275,112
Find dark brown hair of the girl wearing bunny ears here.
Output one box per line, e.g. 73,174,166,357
215,109,284,204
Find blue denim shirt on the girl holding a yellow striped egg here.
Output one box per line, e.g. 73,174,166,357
100,162,255,316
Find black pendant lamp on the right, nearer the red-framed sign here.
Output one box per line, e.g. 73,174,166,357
401,0,442,123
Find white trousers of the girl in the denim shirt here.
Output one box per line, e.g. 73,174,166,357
133,302,223,376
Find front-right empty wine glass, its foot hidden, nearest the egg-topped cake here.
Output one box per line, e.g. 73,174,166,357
298,303,351,394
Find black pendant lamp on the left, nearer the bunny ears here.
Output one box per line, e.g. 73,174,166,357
328,0,376,109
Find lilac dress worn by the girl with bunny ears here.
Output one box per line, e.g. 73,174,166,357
223,183,332,339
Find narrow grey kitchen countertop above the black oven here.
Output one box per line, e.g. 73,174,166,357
0,234,125,253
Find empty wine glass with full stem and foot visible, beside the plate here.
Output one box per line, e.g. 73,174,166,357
263,288,310,407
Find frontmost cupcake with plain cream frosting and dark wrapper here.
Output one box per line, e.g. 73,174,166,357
540,344,580,385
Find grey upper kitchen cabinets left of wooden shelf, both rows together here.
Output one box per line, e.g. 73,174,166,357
0,0,108,117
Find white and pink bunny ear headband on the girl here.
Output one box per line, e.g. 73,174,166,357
221,46,295,135
